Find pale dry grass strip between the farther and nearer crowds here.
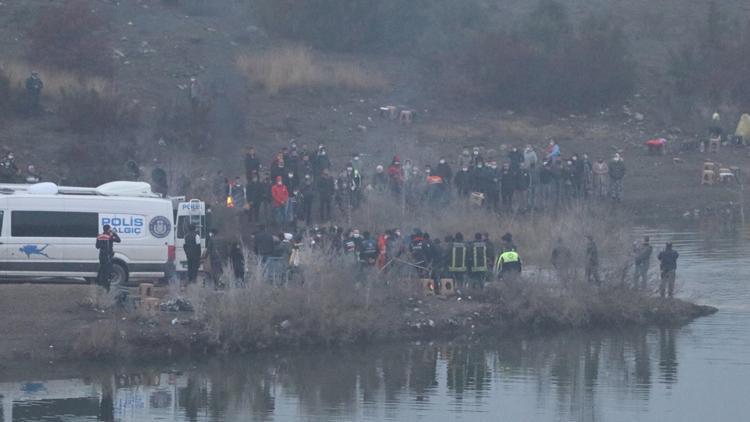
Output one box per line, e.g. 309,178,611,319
352,192,635,268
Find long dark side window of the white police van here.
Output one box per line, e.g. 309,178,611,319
10,211,99,238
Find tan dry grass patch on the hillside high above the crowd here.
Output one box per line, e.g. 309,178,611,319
236,47,386,94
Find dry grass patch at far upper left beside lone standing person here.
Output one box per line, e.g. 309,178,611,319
0,60,111,99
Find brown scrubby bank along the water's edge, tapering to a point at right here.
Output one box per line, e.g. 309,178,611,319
0,284,717,368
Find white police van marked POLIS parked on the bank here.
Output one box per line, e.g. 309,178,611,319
0,182,175,284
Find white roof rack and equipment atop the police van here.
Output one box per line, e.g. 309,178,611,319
0,181,161,198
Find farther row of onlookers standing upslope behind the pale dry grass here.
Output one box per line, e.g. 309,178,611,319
214,141,626,228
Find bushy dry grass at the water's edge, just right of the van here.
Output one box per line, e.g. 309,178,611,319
189,247,408,351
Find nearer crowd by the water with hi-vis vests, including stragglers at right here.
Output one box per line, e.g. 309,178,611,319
228,225,679,297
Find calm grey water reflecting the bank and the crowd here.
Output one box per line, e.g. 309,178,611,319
0,229,750,422
